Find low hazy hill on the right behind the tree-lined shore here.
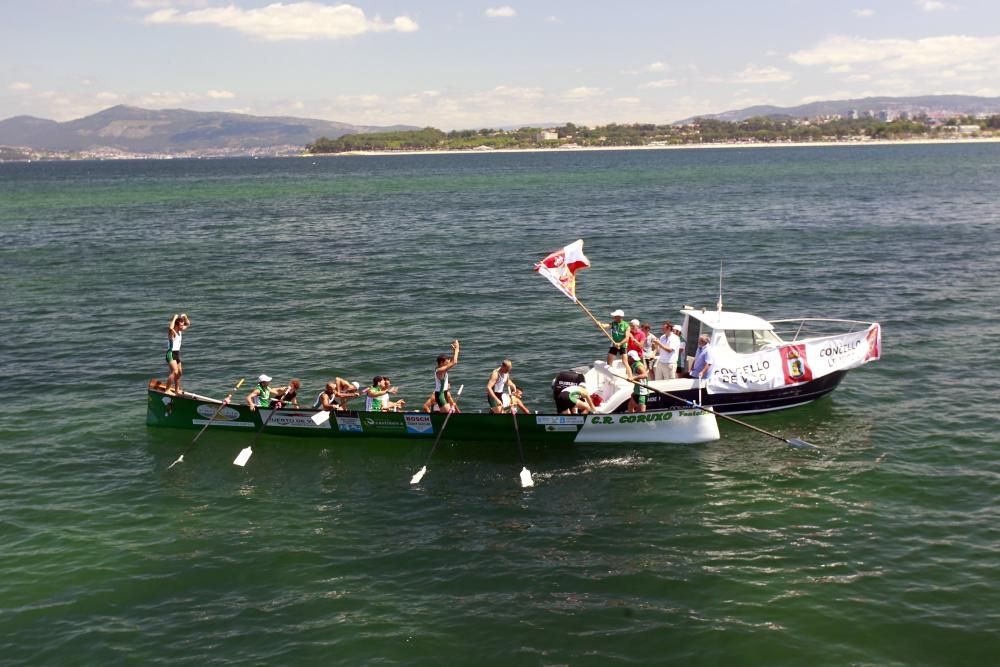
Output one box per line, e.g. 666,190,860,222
677,95,1000,124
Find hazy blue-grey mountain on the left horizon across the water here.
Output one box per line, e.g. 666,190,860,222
0,105,419,155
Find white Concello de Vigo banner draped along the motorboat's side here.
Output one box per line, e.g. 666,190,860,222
707,323,882,394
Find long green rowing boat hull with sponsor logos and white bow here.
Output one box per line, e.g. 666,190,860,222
146,382,719,446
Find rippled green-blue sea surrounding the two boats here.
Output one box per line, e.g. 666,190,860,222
0,144,1000,667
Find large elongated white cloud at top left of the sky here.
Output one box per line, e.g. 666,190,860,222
144,2,419,42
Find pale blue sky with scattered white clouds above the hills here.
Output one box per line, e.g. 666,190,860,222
0,0,1000,130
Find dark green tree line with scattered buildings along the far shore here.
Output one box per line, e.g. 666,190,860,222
306,114,1000,153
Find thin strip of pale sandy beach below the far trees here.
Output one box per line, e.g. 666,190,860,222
312,137,1000,158
